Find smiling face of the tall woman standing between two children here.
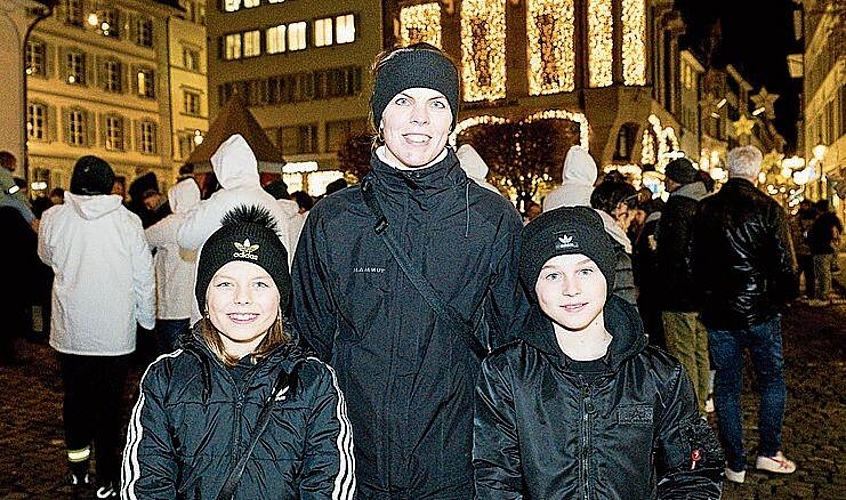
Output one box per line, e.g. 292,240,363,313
381,88,452,168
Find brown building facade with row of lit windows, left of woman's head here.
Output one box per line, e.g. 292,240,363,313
207,0,383,195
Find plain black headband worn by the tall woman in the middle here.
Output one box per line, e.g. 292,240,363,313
370,47,459,130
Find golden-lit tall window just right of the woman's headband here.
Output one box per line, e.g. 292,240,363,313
461,0,506,102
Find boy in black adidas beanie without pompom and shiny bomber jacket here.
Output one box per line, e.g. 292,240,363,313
473,207,724,499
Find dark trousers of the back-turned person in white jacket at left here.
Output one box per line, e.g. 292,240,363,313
59,353,129,485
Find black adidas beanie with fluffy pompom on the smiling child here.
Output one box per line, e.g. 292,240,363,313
194,205,291,312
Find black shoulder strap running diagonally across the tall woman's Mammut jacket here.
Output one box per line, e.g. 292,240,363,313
361,179,488,358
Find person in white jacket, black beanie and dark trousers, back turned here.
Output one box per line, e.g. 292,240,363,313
38,156,156,498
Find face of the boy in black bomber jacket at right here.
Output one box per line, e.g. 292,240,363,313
535,254,607,331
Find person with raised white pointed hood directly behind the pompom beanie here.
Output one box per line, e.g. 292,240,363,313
177,134,296,325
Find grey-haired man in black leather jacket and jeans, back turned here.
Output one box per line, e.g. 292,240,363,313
692,146,799,483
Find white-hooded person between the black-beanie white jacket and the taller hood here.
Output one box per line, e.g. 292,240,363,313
144,177,200,354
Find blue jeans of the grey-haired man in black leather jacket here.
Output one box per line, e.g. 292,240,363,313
708,316,787,472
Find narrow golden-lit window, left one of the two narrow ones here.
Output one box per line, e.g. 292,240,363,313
588,0,614,87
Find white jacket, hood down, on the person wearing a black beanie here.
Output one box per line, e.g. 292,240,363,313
38,192,156,356
